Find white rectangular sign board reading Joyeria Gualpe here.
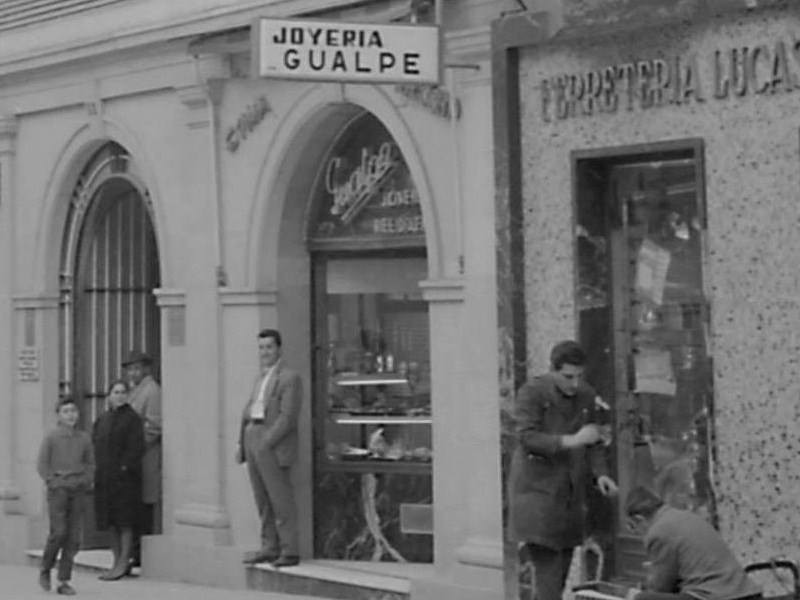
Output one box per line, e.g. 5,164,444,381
253,18,442,83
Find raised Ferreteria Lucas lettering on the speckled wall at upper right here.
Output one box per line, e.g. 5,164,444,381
539,40,800,122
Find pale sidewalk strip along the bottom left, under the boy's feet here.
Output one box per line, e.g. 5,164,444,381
0,565,320,600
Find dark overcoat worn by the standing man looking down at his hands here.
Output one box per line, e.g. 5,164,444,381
508,374,607,550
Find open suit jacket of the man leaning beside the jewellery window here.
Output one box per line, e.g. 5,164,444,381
238,361,303,467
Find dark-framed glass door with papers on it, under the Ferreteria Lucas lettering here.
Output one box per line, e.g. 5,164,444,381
578,147,714,579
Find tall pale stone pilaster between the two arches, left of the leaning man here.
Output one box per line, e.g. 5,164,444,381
170,79,231,544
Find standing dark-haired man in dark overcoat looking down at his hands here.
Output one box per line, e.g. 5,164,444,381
508,341,617,600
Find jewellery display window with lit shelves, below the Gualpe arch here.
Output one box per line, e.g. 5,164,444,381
320,258,432,471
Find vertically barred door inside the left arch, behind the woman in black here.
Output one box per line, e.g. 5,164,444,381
72,179,160,548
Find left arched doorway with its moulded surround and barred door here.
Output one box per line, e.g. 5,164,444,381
59,142,160,547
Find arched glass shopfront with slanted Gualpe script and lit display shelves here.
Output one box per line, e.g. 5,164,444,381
306,111,433,563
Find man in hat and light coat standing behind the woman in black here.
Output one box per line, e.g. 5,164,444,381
122,350,161,564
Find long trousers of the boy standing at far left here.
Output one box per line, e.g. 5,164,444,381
42,487,84,581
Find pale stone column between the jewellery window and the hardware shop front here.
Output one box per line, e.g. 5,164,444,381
414,279,502,599
